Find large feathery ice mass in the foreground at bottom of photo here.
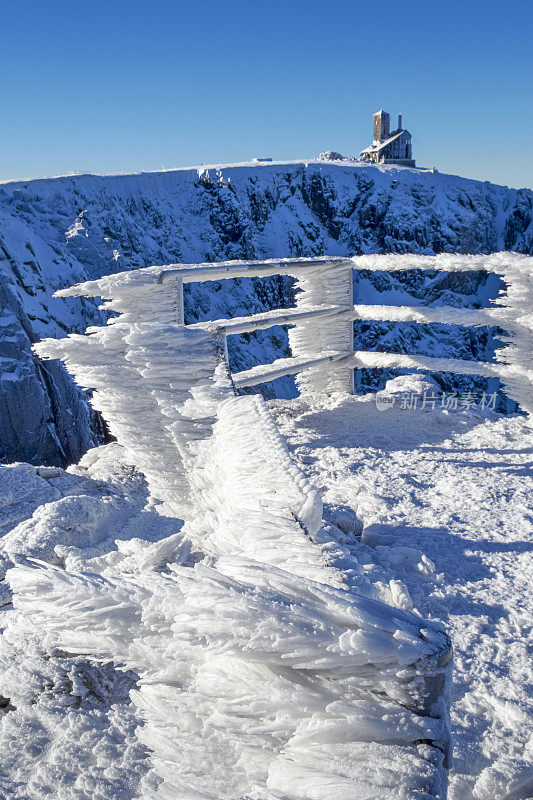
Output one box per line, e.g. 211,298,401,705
8,556,448,800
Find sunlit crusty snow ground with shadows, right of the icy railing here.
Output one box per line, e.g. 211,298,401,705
270,397,533,800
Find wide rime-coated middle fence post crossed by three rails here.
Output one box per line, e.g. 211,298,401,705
289,262,354,395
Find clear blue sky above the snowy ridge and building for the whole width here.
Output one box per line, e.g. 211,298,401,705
0,0,533,187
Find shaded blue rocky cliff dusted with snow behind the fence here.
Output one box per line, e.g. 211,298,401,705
0,161,533,466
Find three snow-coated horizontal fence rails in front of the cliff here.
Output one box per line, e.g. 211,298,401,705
167,253,533,410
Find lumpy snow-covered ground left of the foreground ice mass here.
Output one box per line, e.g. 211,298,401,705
0,445,177,800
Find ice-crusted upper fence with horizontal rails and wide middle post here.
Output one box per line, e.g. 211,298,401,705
48,252,533,413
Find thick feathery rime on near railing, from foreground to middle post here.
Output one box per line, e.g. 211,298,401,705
31,259,458,800
